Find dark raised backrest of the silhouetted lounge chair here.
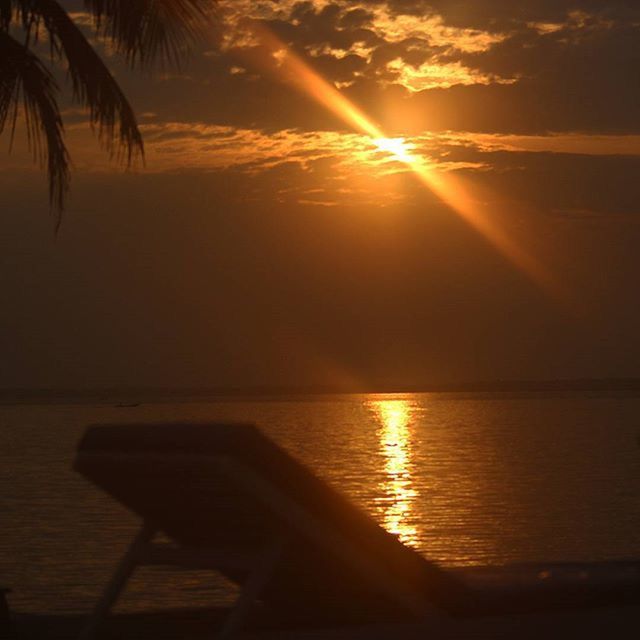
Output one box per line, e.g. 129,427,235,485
75,423,471,622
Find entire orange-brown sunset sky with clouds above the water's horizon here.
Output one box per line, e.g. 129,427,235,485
0,0,640,390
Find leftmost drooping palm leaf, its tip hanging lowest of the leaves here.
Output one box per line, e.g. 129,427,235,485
0,30,69,230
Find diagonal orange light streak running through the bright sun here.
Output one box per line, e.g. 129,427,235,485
256,29,557,291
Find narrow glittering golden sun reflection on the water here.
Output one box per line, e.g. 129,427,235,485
369,399,418,544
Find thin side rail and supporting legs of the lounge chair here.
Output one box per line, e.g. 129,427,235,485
78,452,440,640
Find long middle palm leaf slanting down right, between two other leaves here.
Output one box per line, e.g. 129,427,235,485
14,0,144,163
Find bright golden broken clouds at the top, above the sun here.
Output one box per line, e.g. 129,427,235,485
223,2,510,90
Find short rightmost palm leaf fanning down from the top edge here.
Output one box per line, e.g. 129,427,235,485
84,0,215,67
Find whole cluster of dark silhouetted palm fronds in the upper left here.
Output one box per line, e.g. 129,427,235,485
0,0,216,227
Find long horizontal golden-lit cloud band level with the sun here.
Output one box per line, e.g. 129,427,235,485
46,122,640,215
